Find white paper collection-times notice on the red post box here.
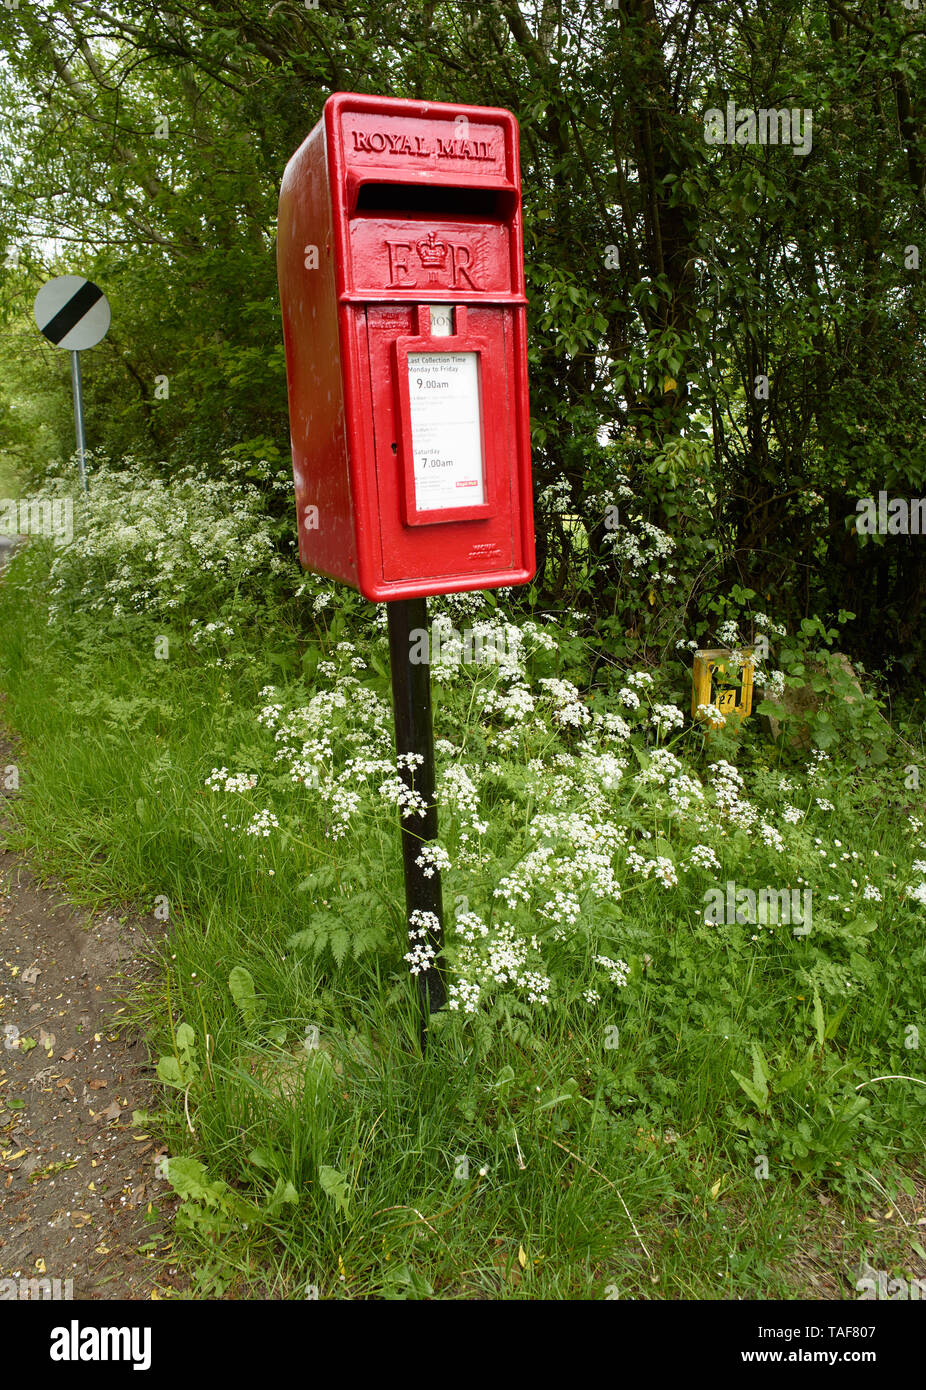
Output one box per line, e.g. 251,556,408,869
409,352,485,512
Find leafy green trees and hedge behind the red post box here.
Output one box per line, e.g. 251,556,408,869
0,0,926,672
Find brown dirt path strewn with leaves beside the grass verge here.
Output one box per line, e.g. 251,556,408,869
0,738,181,1298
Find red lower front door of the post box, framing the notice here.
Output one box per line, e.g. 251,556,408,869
366,303,516,588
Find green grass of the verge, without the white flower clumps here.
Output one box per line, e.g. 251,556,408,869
0,544,926,1300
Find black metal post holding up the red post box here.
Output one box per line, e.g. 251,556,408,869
387,599,446,1051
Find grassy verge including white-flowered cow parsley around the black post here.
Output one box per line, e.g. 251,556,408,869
0,505,926,1298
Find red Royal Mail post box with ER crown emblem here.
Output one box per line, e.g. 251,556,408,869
277,93,535,600
